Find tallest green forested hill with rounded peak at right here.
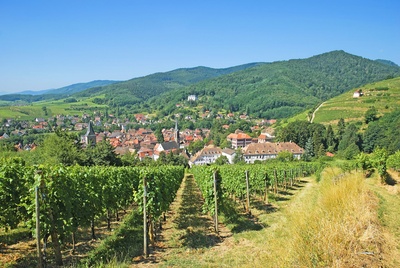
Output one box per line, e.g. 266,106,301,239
147,51,400,118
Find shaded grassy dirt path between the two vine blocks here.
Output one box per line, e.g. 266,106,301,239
132,175,232,267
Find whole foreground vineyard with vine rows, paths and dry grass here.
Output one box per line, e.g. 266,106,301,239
0,158,390,267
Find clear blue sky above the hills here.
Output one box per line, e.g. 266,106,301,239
0,0,400,93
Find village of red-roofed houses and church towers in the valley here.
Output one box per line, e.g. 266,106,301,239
0,106,304,166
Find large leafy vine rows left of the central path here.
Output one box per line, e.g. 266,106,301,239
0,158,184,265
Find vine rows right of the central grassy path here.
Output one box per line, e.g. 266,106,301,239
191,162,321,231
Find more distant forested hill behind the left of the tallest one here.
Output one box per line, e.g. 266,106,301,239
76,63,260,106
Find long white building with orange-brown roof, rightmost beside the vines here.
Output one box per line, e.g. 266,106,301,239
243,142,304,164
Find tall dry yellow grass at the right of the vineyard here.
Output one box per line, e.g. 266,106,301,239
289,169,384,267
